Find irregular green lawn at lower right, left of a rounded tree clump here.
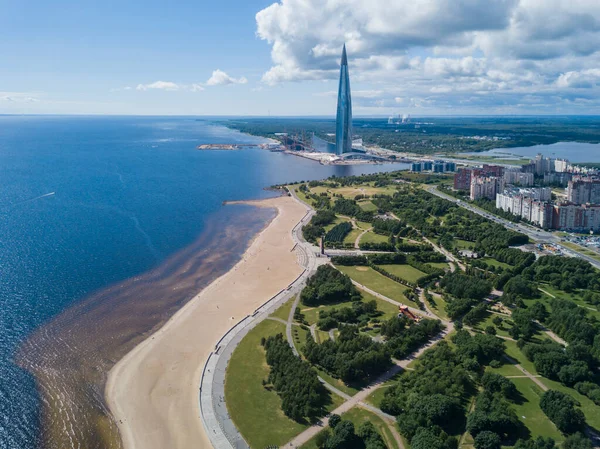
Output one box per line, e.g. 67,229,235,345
510,378,564,443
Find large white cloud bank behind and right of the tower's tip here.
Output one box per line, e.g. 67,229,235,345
256,0,600,112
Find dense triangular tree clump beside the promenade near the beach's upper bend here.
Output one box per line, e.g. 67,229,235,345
300,265,361,306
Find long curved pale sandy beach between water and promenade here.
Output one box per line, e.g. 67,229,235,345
105,197,306,449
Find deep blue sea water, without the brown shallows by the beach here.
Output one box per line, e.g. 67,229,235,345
0,116,406,449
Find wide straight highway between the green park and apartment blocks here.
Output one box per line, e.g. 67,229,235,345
425,186,600,270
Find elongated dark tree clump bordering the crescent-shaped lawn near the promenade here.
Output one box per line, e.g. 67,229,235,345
262,334,330,422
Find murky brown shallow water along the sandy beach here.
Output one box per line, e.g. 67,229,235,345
17,206,275,449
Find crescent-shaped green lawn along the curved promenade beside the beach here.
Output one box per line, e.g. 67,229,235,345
225,320,307,449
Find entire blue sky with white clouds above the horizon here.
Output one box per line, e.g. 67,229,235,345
0,0,600,117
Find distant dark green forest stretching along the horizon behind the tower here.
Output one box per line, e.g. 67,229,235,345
218,117,600,154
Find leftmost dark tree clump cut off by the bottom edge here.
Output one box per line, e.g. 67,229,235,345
315,415,387,449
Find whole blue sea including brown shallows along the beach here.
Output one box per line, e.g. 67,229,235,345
0,116,406,449
